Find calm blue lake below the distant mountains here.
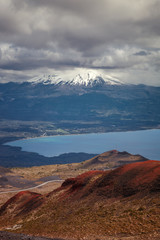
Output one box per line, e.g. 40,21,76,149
7,129,160,160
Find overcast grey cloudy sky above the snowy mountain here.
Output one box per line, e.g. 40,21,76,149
0,0,160,86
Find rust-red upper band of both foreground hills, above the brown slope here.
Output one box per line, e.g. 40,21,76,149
0,160,160,223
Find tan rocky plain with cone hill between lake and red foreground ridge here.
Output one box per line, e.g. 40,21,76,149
0,150,147,206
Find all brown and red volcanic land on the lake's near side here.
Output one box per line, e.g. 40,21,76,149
0,139,160,240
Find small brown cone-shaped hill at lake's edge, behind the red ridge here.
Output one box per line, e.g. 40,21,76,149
80,150,148,170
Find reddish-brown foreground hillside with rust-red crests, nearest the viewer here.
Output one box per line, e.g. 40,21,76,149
0,160,160,239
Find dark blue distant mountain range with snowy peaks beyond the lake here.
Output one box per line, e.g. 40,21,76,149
0,72,160,132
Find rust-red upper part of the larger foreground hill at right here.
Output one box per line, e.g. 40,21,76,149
54,160,160,199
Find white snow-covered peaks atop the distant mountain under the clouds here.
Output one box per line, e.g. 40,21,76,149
28,72,124,87
